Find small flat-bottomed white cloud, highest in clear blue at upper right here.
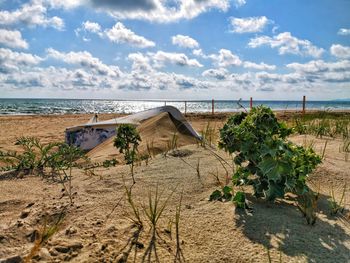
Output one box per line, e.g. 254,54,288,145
230,16,270,33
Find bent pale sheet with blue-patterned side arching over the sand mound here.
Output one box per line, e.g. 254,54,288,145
65,106,201,150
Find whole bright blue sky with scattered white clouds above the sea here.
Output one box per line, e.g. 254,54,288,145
0,0,350,100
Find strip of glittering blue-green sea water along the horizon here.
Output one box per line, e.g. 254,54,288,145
0,99,350,115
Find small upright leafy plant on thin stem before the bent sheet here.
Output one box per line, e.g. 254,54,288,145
114,124,141,184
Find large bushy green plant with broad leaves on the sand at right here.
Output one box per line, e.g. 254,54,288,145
219,106,321,225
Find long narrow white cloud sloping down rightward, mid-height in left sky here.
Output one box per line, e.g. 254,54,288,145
46,48,120,77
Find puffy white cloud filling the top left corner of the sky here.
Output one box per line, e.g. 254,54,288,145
0,0,64,30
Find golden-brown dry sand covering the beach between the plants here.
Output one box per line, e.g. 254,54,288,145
0,112,350,262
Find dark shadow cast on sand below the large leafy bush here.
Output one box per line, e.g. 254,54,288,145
234,195,350,263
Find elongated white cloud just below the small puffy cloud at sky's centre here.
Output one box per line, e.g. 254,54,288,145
149,51,203,67
